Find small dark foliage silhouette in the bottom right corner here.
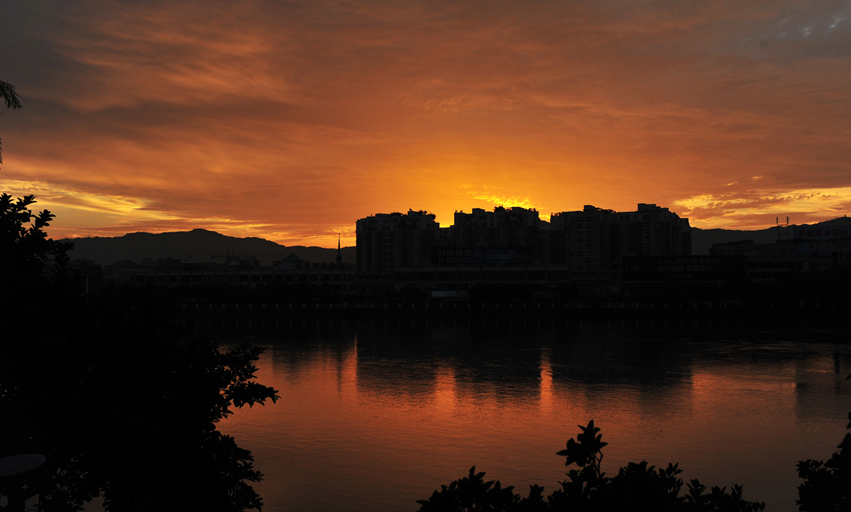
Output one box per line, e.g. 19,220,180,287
797,375,851,512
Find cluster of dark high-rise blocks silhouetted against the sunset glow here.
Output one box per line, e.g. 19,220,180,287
357,204,691,293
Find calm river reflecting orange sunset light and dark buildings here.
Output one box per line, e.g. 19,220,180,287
220,318,851,512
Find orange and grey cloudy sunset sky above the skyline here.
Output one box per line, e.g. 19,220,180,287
0,0,851,247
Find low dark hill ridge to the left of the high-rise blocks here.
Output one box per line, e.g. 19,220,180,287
63,229,355,266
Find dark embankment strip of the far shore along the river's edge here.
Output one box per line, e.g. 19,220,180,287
173,302,851,340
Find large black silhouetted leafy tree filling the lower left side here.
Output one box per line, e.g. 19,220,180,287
0,194,278,511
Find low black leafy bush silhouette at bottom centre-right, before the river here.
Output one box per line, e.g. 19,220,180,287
417,420,765,512
